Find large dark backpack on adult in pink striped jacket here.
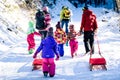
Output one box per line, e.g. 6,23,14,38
36,11,46,30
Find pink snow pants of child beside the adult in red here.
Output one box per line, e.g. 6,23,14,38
69,39,78,57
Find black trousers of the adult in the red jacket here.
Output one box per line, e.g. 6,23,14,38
84,31,94,53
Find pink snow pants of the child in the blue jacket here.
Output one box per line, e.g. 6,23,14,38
42,58,56,76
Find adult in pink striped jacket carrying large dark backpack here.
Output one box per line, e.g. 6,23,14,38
35,6,51,40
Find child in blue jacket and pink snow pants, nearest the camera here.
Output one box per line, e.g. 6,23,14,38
33,27,59,77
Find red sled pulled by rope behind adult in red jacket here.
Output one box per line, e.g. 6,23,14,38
89,55,107,71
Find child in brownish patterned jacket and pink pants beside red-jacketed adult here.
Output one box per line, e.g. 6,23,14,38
68,24,78,58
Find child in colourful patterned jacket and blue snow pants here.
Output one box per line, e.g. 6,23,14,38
54,22,67,57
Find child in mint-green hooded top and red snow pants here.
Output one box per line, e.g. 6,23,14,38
27,21,40,54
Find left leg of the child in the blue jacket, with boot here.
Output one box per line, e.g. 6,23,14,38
42,58,49,77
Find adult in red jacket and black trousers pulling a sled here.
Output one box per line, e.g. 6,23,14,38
80,6,98,54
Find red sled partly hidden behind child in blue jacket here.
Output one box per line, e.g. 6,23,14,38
32,59,42,71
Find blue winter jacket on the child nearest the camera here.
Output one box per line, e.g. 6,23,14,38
35,36,58,58
